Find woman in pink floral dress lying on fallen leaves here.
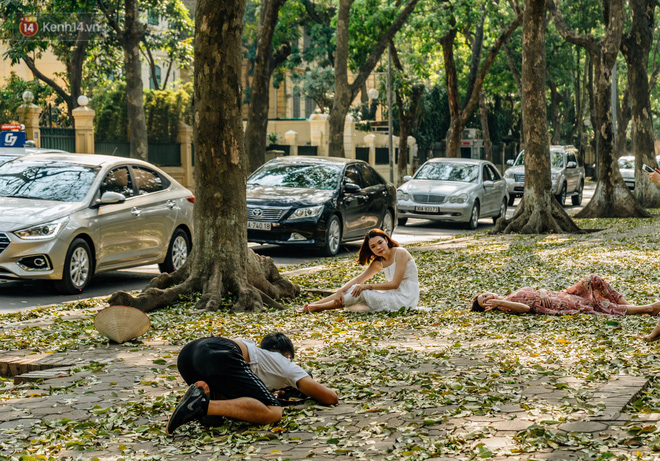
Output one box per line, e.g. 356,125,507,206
471,275,660,316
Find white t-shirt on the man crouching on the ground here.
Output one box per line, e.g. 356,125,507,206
236,338,309,391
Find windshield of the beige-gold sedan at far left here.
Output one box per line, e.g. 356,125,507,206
0,161,100,202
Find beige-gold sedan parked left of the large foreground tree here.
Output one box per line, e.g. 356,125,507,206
0,154,194,293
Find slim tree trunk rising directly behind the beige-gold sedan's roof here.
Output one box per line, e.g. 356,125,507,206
121,0,149,160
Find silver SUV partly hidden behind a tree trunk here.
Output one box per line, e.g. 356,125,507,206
504,146,585,206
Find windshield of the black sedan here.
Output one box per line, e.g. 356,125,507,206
247,162,343,190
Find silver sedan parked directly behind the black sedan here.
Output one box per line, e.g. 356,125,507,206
397,158,508,229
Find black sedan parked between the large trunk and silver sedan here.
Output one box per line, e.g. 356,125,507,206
247,156,396,255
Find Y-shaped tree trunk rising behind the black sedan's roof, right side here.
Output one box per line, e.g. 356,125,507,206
328,0,419,157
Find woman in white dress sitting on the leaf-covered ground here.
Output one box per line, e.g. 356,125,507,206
298,229,419,312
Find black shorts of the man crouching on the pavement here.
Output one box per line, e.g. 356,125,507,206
177,337,280,406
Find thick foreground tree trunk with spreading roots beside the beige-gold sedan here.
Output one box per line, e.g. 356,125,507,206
109,0,299,311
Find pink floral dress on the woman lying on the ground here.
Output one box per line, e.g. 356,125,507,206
500,275,628,315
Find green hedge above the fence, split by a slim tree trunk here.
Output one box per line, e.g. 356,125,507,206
92,81,193,143
